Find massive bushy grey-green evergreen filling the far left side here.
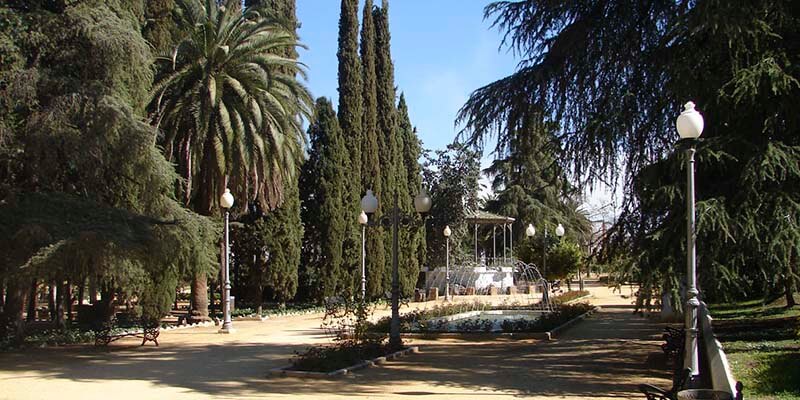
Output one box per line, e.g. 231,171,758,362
0,1,219,335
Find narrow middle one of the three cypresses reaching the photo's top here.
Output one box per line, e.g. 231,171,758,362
361,0,387,298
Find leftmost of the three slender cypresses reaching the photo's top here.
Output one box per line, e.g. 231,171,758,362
337,0,363,296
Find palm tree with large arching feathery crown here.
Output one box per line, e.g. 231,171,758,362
150,0,313,319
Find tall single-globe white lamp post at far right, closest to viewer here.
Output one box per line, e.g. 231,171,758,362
675,101,704,378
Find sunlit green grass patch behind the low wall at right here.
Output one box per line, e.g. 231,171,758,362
709,298,800,400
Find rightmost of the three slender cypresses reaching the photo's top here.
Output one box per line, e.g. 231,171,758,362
372,0,400,289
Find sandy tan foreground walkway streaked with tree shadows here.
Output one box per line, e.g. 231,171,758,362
0,284,669,400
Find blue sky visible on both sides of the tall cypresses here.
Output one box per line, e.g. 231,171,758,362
297,0,516,155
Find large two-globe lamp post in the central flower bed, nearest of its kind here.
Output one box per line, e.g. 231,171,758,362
361,189,432,349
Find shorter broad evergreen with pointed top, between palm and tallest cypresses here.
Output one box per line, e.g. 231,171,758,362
300,97,351,301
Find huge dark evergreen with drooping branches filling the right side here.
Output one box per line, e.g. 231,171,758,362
459,0,800,304
